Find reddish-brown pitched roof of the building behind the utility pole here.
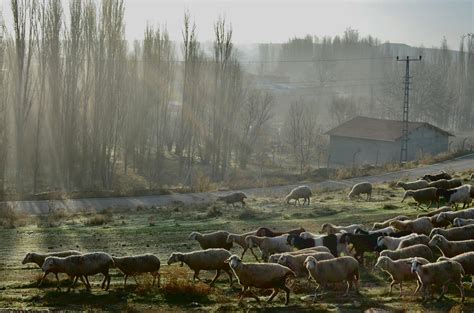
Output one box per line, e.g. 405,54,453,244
326,116,454,141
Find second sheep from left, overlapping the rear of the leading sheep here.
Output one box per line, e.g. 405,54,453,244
41,252,115,291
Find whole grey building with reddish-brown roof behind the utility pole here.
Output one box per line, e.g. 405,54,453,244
326,116,454,167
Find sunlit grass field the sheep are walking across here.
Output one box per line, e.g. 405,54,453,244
0,185,474,312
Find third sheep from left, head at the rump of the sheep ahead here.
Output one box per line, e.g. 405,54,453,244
112,254,160,288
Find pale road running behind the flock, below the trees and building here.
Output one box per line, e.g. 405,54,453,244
4,154,474,214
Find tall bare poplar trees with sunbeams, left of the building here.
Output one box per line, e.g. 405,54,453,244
0,0,274,195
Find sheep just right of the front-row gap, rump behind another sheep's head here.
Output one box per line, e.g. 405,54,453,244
375,256,430,297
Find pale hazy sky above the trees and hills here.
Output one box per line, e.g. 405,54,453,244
0,0,474,50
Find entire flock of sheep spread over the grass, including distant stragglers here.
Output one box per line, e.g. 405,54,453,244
22,172,474,304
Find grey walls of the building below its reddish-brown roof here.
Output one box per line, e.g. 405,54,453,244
329,127,449,167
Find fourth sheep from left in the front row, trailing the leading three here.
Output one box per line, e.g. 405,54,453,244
168,248,232,286
